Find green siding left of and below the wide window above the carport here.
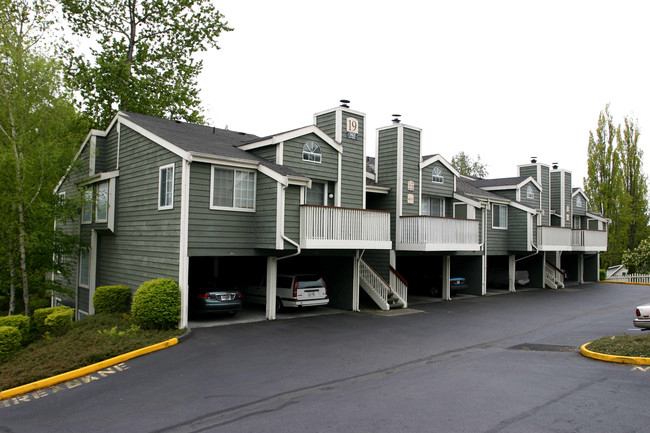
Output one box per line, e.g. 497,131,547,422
189,162,254,256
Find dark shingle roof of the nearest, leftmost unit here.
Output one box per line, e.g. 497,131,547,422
120,111,305,177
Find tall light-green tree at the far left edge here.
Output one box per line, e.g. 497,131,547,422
0,0,86,314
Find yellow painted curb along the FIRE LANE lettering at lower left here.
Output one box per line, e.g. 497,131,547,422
0,338,178,400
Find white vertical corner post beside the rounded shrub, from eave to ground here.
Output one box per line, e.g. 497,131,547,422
178,160,191,329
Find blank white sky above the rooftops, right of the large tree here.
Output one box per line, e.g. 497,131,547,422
199,0,650,186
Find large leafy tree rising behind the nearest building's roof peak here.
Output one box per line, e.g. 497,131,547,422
59,0,232,127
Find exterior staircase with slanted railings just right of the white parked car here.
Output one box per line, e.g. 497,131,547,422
359,259,408,311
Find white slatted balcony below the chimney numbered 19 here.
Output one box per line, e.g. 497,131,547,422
300,205,392,250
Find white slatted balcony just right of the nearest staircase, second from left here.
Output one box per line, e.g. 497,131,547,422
397,216,481,251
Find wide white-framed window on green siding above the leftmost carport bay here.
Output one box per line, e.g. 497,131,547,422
210,166,256,211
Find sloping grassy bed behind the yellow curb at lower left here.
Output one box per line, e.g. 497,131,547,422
0,313,184,390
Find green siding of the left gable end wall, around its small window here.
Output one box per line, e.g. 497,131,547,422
97,127,182,290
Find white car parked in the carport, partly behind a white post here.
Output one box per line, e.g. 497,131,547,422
244,274,329,311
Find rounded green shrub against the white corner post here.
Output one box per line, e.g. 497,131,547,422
131,278,181,329
